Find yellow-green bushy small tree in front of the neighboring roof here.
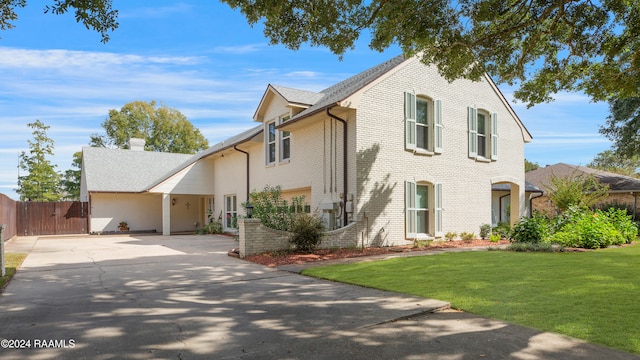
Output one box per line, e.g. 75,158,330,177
545,173,609,213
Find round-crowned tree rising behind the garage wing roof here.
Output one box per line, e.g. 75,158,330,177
91,101,209,154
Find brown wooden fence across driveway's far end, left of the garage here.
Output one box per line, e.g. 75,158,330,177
16,201,89,236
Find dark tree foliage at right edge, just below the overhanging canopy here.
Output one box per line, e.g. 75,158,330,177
600,96,640,159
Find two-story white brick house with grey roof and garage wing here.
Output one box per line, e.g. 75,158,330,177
82,56,531,245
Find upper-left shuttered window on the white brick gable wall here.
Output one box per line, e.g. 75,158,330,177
404,92,443,154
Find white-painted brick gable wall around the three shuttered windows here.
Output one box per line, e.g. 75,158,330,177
356,60,525,245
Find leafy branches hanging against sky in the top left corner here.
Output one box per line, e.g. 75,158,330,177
0,0,118,43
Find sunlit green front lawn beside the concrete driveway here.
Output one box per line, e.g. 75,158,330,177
303,245,640,354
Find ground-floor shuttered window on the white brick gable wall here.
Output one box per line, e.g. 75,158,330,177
405,181,443,239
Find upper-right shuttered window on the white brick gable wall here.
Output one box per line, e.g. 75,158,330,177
467,107,498,160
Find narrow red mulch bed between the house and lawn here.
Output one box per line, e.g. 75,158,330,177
245,240,509,267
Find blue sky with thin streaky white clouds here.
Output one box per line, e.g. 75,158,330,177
0,0,611,198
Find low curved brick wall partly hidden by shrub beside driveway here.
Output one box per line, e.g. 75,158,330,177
238,219,357,258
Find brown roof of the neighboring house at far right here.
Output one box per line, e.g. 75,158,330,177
525,163,640,192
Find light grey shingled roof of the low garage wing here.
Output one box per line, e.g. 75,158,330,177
82,147,192,192
